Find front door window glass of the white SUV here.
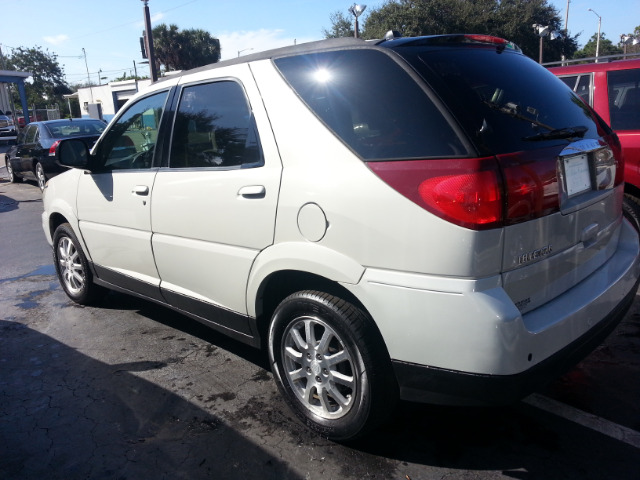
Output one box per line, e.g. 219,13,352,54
96,92,168,170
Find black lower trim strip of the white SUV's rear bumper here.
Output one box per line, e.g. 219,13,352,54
392,278,638,405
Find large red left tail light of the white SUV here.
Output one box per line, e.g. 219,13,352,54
368,152,559,230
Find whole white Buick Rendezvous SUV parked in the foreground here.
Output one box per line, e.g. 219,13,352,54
42,35,640,440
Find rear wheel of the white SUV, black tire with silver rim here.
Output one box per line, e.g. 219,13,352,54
269,291,397,441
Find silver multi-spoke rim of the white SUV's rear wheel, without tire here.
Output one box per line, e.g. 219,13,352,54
282,316,358,420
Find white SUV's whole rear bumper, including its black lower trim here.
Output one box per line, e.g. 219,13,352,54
352,221,640,405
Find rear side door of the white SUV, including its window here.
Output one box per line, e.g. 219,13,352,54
152,65,282,326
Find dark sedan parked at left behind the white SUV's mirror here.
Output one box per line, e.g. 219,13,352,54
5,118,107,189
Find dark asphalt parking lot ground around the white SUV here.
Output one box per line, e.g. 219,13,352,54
0,153,640,480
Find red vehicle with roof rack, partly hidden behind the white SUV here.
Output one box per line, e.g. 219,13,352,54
549,59,640,229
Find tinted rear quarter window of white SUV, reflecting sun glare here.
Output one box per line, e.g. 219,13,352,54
275,49,467,160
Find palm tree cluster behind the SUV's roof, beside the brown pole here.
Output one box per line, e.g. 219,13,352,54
153,23,220,71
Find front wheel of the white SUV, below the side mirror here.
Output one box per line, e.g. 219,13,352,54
53,223,104,305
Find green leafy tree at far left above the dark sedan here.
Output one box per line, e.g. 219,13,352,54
7,46,71,110
